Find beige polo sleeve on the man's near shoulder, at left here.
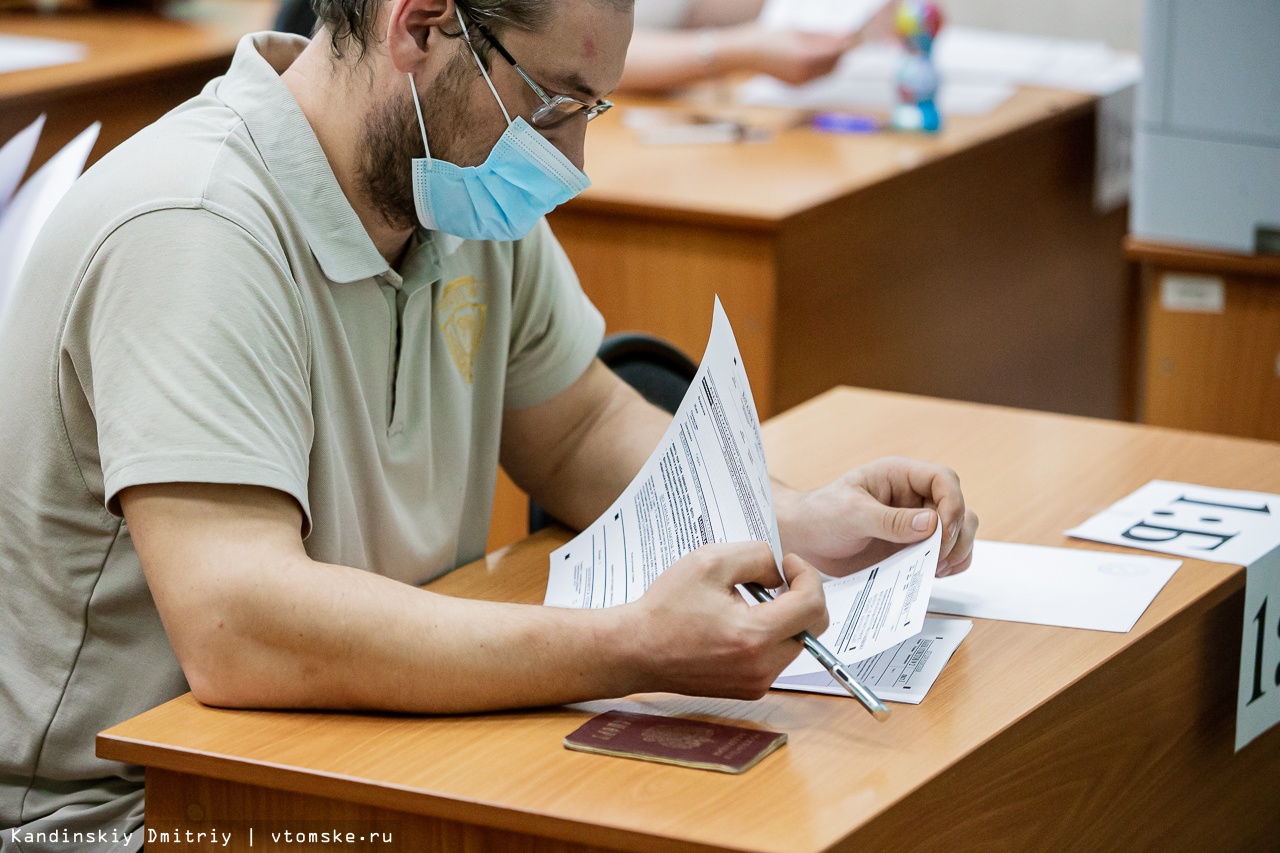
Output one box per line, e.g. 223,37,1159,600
65,209,314,533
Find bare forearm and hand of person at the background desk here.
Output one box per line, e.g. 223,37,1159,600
620,0,891,92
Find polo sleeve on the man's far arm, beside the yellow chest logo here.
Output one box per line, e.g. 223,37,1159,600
503,219,604,409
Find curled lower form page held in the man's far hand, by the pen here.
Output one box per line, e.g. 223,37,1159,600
780,524,942,678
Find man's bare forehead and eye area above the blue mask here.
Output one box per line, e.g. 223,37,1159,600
500,0,631,97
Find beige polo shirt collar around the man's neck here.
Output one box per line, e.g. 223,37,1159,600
216,32,389,283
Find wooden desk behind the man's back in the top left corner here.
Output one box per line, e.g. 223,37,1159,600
0,0,275,176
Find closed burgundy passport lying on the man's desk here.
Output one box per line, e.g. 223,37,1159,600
564,711,787,774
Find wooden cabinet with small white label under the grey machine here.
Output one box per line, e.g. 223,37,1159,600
1125,238,1280,441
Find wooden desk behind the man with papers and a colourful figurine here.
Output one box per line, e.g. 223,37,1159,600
549,88,1130,418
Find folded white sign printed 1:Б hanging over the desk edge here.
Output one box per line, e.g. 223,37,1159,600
1066,480,1280,751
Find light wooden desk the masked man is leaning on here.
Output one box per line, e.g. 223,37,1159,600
97,389,1280,852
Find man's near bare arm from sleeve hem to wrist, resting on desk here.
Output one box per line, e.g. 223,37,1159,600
120,483,645,712
